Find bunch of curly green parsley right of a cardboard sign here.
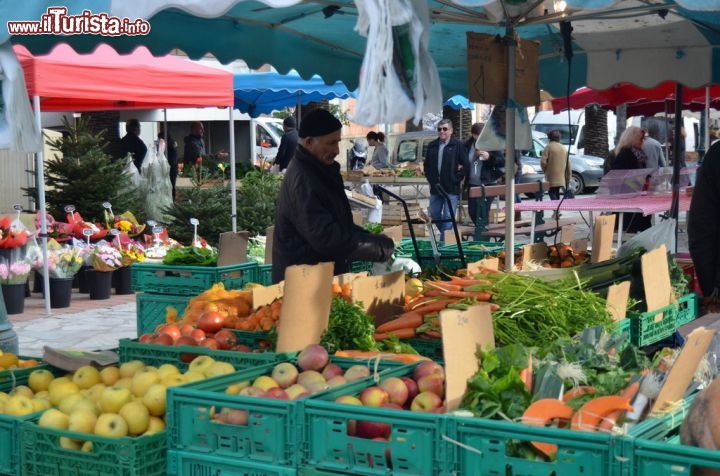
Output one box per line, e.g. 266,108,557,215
320,296,379,354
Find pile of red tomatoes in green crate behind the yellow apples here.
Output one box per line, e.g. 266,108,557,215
138,322,253,356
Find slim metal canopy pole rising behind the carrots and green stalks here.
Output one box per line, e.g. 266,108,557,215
505,26,515,271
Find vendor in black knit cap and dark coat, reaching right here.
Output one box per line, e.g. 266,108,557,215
272,109,395,283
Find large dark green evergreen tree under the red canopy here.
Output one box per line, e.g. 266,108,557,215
24,118,145,223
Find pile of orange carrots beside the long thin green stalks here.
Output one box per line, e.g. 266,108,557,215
375,276,499,342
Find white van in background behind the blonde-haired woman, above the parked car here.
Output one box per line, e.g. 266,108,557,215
530,109,617,155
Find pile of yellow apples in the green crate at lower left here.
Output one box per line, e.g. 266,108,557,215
0,355,235,451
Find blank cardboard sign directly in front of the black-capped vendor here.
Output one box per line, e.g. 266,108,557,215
276,263,334,352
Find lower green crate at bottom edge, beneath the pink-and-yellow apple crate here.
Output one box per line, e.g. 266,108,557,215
167,450,298,476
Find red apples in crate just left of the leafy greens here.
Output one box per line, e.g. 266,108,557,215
335,360,445,440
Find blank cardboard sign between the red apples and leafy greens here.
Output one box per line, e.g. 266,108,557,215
440,303,495,411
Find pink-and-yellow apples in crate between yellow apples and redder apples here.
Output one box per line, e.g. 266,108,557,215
213,344,370,425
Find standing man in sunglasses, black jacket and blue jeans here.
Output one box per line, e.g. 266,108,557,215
423,119,470,243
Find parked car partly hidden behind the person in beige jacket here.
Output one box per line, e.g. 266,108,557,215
520,131,605,195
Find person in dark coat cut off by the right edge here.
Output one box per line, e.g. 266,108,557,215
687,142,720,312
